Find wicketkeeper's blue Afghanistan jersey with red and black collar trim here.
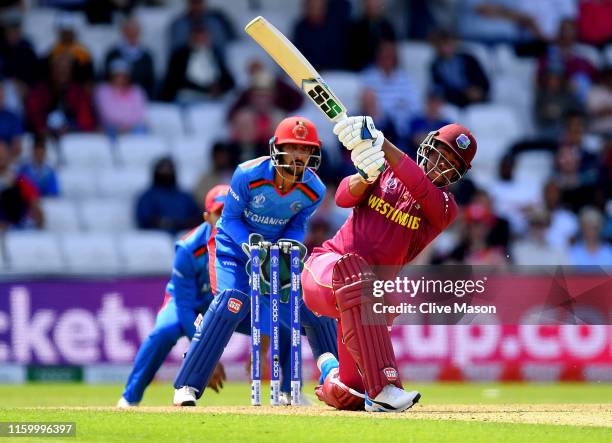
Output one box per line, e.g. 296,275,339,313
215,157,325,259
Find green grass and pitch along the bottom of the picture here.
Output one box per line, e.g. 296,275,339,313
0,383,612,443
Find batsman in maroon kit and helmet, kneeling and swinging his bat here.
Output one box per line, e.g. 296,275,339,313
302,116,476,412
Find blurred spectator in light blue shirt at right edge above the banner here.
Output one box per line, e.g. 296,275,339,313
570,207,612,266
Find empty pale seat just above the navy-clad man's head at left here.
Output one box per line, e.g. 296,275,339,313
117,134,170,169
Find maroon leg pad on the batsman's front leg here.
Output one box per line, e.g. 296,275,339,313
332,254,402,398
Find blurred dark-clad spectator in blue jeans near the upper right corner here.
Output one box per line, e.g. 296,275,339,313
538,19,596,102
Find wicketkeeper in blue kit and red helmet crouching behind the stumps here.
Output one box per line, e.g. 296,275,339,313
174,116,337,406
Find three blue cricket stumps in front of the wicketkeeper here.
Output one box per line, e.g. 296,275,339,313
251,242,302,406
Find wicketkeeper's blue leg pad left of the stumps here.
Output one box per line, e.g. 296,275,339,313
174,289,250,398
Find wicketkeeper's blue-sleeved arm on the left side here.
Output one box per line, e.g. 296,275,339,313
222,167,249,246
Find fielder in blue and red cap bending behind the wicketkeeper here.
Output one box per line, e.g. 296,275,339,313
117,185,229,408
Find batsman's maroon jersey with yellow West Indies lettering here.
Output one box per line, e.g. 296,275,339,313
322,155,457,277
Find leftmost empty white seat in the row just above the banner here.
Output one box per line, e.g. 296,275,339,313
5,231,65,274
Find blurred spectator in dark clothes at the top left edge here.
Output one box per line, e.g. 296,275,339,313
0,11,40,90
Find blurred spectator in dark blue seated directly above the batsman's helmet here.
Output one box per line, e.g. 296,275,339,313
430,30,489,108
